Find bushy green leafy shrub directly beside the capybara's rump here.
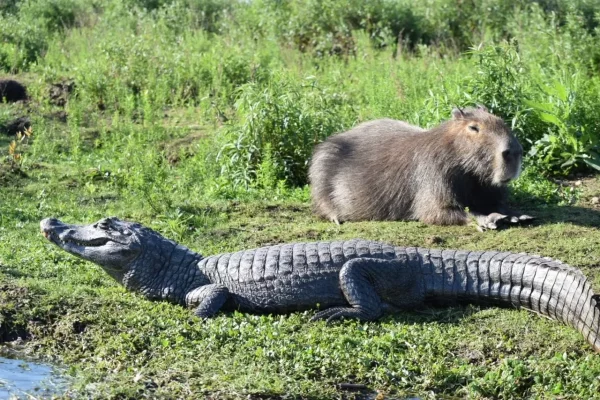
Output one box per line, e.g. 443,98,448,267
218,76,353,186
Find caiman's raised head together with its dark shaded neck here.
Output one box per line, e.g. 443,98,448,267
40,217,206,301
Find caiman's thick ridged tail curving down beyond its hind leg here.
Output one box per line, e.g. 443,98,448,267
414,249,600,352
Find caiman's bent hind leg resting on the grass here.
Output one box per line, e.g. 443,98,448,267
312,258,422,322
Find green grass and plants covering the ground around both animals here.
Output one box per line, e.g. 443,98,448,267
0,0,600,399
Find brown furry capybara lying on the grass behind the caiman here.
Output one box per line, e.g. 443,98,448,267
309,106,522,224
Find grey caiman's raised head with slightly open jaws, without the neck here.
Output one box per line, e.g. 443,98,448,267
40,217,146,283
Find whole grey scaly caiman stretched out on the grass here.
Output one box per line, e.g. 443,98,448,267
41,218,600,352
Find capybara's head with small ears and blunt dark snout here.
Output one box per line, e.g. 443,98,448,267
450,105,523,186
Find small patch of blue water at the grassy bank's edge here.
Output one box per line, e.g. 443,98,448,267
0,357,66,400
